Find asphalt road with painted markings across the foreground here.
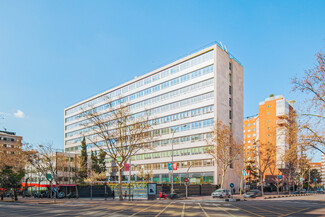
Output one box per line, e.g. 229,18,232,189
0,194,325,217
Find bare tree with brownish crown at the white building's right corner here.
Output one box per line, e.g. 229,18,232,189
206,120,243,188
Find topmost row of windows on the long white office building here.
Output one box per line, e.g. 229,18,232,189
65,51,213,115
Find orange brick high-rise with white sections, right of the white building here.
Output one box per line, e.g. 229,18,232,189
244,95,293,182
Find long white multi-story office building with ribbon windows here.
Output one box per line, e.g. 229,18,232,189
64,44,243,187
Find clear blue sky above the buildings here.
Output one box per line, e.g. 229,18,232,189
0,0,325,159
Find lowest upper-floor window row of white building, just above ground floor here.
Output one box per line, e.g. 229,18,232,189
107,159,214,173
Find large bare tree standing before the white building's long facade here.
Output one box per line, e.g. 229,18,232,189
85,99,153,200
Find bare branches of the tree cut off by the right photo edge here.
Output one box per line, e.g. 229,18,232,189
292,52,325,154
